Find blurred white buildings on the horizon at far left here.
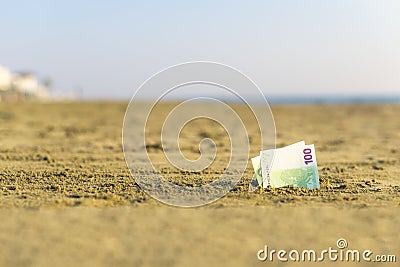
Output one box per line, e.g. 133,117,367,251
0,66,49,100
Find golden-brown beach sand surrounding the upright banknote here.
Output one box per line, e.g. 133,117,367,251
0,102,400,266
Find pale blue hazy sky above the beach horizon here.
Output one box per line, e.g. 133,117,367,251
0,0,400,99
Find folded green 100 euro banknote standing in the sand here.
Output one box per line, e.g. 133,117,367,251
252,141,319,189
